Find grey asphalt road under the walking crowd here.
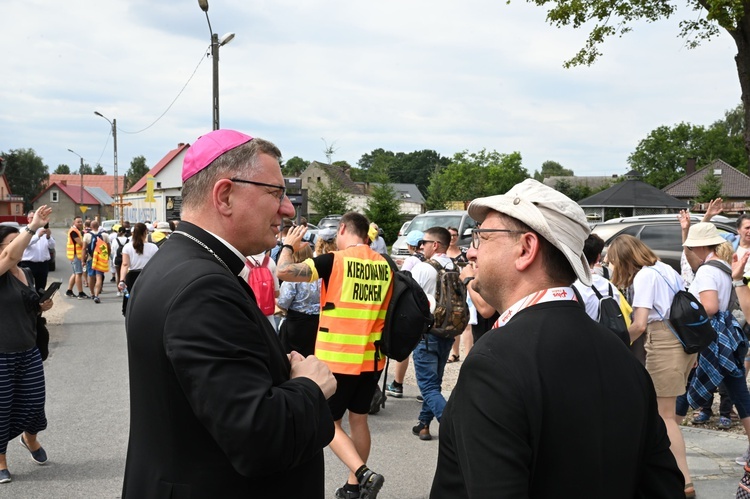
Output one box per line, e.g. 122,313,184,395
0,229,747,499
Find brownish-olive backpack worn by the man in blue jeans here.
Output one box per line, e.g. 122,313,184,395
425,259,469,338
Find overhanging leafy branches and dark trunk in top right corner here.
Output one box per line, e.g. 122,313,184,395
527,0,750,161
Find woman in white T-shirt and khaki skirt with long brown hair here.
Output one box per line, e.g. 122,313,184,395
607,235,697,497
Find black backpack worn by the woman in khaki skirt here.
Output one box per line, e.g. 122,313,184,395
649,267,717,353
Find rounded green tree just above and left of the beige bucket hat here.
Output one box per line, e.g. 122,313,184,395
427,149,529,209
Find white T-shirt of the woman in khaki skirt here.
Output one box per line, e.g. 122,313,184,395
633,261,683,323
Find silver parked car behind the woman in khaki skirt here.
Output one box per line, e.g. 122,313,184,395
591,214,737,273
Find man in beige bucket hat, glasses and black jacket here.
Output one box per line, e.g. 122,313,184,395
430,179,684,499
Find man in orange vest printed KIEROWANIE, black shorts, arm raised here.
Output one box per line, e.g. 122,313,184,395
276,212,393,499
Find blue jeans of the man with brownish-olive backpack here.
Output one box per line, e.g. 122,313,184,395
412,334,453,425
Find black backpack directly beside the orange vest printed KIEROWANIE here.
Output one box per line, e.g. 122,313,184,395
375,254,434,362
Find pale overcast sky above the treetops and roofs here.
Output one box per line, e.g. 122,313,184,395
0,0,740,180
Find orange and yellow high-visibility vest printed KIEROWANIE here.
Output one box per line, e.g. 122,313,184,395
315,244,393,375
